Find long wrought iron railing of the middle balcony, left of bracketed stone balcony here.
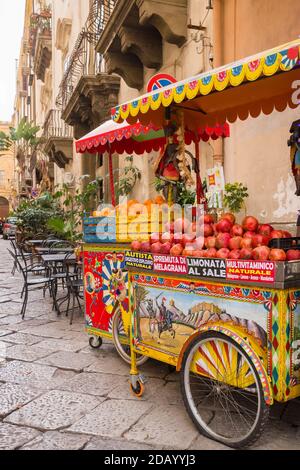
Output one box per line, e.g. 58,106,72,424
56,0,119,110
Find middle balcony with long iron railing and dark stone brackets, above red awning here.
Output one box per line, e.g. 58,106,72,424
56,0,120,134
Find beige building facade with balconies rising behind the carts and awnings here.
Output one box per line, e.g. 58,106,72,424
16,0,300,223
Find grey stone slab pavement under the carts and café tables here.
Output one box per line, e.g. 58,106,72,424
0,240,300,450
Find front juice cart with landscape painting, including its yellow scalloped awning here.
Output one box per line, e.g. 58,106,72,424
112,40,300,447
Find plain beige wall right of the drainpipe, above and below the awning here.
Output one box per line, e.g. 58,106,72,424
221,0,300,222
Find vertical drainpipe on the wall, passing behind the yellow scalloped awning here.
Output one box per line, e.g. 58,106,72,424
213,0,224,165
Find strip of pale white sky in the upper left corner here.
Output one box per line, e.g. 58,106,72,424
0,0,25,121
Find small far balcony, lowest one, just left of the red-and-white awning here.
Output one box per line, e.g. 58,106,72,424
43,109,73,168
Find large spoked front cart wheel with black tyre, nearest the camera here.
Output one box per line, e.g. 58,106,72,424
181,332,269,448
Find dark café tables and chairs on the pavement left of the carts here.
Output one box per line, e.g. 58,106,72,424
8,236,83,324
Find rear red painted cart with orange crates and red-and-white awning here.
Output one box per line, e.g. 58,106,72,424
76,117,229,363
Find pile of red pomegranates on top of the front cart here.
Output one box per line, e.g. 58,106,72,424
131,213,300,261
